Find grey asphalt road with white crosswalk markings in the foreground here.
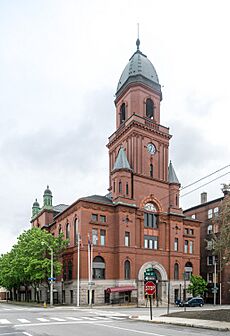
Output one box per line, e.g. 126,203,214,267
0,303,230,336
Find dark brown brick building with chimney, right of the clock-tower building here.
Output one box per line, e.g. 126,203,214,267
184,185,230,304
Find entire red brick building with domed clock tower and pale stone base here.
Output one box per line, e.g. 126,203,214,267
31,39,200,304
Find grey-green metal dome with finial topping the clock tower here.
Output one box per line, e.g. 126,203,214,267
116,38,161,97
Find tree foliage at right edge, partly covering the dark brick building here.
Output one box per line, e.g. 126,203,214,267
212,195,230,264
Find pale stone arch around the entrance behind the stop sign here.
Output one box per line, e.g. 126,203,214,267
137,261,168,305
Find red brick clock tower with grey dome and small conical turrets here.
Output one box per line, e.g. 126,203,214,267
108,39,181,212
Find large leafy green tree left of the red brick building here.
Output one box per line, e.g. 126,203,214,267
0,228,68,300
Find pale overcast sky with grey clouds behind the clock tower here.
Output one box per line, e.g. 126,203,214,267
0,0,230,253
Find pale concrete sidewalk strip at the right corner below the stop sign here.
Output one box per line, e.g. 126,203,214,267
130,315,230,331
